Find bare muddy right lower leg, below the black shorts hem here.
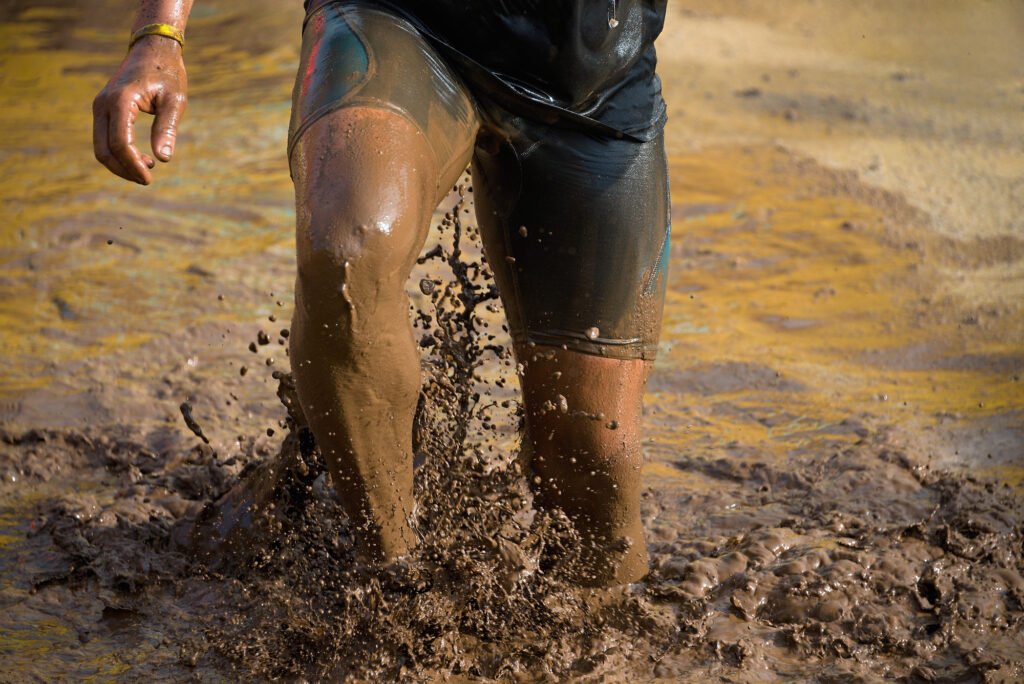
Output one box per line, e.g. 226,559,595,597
517,346,649,586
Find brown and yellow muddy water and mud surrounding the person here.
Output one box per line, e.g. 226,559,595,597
0,0,1024,681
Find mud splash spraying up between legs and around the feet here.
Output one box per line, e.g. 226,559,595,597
180,185,675,681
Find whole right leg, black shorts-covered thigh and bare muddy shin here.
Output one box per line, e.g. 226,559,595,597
473,121,669,585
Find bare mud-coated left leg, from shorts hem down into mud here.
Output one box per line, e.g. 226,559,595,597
292,108,446,560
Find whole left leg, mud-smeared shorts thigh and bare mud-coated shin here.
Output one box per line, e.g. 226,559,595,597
290,3,476,560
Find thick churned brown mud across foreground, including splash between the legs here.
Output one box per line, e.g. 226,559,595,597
0,188,1024,682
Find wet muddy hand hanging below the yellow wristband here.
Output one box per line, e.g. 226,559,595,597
92,36,187,185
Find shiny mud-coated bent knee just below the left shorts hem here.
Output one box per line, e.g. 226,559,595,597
293,106,436,305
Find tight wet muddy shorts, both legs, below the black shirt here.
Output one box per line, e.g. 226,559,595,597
289,1,671,359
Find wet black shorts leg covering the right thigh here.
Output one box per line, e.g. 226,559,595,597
473,125,671,359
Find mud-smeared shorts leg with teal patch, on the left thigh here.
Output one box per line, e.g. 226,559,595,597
288,1,477,200
